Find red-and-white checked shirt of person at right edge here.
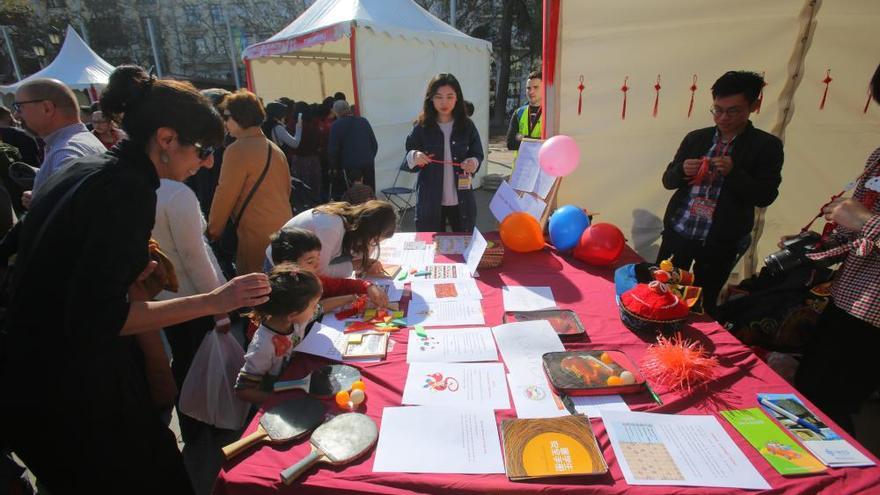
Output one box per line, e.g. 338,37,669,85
810,148,880,328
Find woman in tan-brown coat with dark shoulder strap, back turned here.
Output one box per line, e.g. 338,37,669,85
208,90,293,274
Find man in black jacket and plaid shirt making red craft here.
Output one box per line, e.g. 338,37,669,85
657,71,783,314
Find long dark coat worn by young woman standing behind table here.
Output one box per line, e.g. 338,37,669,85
402,119,483,232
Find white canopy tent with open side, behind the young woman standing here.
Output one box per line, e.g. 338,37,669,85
244,0,491,198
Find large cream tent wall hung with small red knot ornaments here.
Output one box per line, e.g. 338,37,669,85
544,0,880,280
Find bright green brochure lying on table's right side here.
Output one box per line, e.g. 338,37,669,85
721,407,825,476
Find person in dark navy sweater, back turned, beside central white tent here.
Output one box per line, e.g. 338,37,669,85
327,100,379,189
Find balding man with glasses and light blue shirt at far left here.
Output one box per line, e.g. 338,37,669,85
12,79,107,207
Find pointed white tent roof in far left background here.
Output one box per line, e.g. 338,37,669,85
0,26,115,93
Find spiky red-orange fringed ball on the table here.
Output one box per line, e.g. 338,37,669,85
642,333,718,392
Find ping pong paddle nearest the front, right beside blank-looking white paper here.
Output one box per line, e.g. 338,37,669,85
281,413,379,485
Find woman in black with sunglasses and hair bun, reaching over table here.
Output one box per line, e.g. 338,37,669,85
0,66,269,493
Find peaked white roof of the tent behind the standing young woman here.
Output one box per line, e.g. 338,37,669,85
244,0,492,59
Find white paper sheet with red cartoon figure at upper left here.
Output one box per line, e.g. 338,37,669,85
401,363,510,409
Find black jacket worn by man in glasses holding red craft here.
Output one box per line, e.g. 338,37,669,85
663,122,784,243
